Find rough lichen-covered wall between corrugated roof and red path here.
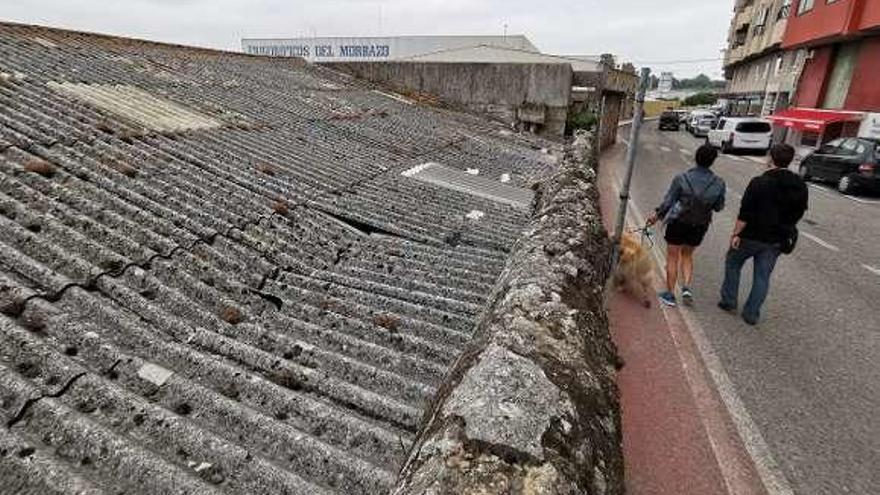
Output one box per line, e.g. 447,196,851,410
394,136,624,495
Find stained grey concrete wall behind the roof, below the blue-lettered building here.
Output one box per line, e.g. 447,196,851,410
322,62,573,136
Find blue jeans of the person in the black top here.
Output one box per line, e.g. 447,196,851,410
721,239,779,323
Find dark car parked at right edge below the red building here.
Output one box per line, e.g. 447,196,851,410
799,138,880,194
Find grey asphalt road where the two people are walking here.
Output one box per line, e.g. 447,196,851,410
616,122,880,495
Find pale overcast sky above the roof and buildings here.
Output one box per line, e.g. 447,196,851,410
0,0,733,78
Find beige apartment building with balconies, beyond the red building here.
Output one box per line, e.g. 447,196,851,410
724,0,804,115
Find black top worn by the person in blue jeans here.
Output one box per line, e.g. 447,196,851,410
739,168,809,244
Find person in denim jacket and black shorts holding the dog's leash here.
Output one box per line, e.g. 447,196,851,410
648,145,727,307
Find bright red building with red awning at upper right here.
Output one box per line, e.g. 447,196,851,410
770,0,880,146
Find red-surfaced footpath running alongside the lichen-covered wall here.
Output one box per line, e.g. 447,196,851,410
599,141,767,495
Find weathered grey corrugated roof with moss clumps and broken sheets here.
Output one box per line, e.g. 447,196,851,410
0,24,549,495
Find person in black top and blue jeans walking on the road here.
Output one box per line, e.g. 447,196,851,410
718,144,809,325
